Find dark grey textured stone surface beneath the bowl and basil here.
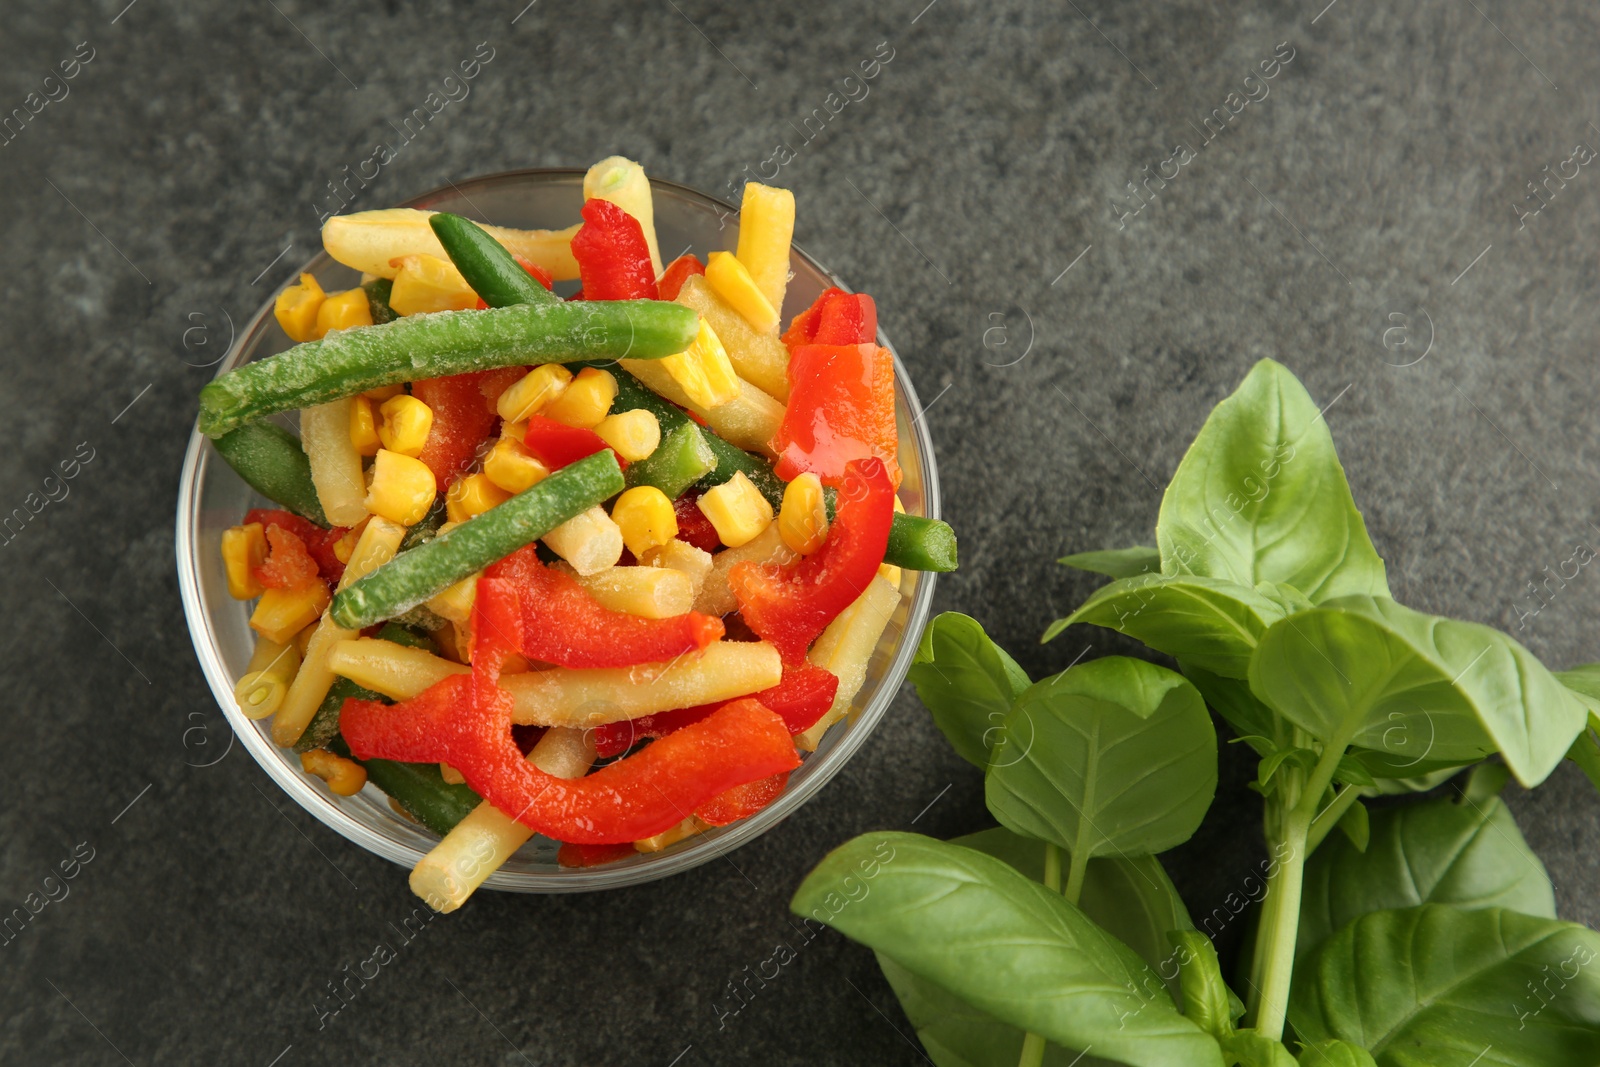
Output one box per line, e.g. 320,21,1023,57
0,0,1600,1067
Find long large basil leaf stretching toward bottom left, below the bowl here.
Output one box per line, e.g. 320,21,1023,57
790,832,1222,1067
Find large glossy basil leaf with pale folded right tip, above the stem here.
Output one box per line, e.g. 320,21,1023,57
1250,597,1584,789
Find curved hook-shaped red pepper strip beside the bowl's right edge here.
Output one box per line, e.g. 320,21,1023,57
728,458,894,664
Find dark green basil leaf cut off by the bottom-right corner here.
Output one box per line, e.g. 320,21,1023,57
1290,904,1600,1067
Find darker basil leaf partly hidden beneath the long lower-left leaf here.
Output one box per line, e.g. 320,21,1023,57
877,952,1117,1067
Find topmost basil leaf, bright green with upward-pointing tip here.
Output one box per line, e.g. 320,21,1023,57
1155,360,1389,603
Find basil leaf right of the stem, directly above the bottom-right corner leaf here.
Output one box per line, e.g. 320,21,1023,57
1294,797,1555,960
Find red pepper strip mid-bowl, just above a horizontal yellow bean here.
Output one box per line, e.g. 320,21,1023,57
477,545,723,667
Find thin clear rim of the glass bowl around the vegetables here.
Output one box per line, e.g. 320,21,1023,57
176,168,939,893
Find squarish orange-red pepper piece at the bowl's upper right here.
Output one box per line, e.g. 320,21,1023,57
771,344,901,488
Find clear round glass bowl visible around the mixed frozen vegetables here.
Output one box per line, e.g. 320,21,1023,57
178,170,939,893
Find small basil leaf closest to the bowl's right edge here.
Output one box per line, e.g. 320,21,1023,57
907,611,1029,768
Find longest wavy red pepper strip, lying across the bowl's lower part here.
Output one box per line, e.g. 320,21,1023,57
339,694,800,845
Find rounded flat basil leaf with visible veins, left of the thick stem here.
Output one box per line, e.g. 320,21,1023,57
984,656,1216,857
